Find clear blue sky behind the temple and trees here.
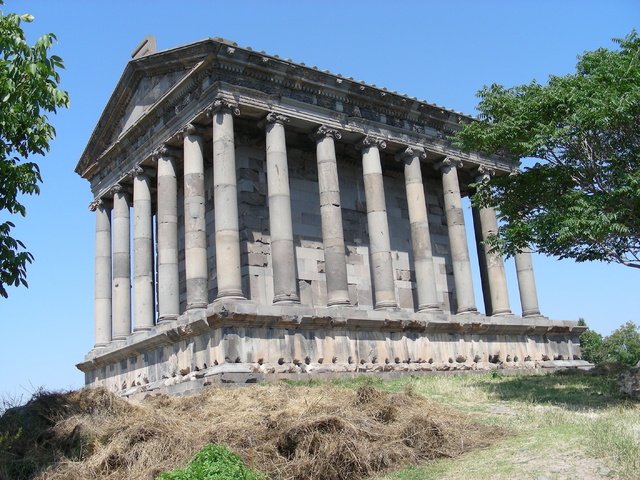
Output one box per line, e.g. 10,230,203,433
0,0,640,397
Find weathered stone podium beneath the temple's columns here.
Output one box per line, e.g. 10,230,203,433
78,300,587,395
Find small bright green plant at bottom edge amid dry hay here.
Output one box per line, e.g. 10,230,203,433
156,443,266,480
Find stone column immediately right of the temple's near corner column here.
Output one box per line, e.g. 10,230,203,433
266,113,300,303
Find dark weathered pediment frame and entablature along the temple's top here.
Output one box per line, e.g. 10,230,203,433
76,39,509,189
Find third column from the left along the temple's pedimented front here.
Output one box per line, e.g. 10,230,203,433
131,167,155,331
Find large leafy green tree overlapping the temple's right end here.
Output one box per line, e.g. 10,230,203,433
453,31,640,268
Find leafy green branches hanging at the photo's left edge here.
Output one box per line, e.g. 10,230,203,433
0,0,69,297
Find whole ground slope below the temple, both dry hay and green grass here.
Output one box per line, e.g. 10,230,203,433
0,372,640,480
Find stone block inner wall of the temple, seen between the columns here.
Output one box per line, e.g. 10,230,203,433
168,136,455,311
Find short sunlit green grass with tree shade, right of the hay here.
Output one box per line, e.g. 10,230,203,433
342,372,640,480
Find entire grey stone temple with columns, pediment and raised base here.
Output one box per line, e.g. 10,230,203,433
76,38,586,394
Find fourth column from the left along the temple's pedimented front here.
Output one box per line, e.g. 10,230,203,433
155,147,181,322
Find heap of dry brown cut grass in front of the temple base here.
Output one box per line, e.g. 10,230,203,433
0,384,504,480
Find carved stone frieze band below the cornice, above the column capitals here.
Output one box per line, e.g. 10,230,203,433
85,48,512,193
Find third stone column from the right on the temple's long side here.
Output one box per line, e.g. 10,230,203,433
436,158,477,313
